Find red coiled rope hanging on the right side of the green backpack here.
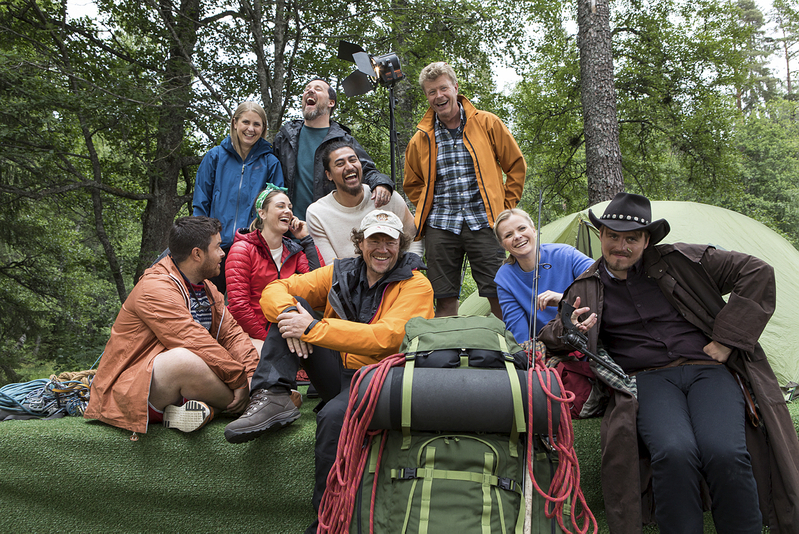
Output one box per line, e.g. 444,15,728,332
527,354,598,534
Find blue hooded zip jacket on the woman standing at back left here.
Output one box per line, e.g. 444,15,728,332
193,136,283,248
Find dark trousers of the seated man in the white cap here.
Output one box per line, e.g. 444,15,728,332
251,297,355,532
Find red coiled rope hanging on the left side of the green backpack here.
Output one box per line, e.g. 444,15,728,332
317,354,405,533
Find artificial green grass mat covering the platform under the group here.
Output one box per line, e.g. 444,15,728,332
0,399,799,534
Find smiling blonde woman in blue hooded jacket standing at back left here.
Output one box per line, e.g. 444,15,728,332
193,102,283,293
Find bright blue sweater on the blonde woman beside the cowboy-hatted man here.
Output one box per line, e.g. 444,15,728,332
494,243,594,343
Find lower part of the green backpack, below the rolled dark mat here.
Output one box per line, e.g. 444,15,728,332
350,430,524,534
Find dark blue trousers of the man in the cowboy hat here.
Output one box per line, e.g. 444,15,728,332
637,365,762,534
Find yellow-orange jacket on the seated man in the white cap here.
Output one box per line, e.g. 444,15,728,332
261,253,433,369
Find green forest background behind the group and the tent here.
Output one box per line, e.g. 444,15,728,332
0,0,799,384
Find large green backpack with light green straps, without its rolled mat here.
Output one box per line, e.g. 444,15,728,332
350,316,566,534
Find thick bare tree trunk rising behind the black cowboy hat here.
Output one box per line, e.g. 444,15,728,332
577,0,624,205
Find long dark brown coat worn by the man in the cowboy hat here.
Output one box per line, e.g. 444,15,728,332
541,243,799,534
